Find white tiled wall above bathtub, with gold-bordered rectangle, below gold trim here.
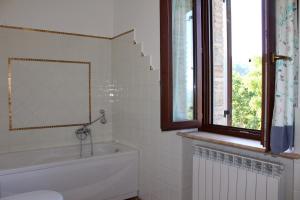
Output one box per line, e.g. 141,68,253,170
0,28,112,153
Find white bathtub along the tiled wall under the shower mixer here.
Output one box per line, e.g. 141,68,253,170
0,142,138,200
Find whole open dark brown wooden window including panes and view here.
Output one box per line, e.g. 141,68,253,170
161,0,275,147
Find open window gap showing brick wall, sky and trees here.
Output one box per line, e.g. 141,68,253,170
212,0,262,130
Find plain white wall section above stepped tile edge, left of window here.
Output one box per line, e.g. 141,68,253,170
114,0,160,69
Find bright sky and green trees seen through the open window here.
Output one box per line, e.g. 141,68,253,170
231,0,262,130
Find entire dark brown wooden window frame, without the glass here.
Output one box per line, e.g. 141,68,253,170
160,0,276,149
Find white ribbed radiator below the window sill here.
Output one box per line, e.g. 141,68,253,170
193,145,283,200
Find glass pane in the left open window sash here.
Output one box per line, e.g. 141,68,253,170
172,0,194,122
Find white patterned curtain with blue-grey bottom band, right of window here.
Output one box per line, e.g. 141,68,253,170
271,0,299,153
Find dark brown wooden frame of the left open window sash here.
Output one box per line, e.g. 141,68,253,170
160,0,202,131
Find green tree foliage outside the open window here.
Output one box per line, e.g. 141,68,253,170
232,57,262,130
